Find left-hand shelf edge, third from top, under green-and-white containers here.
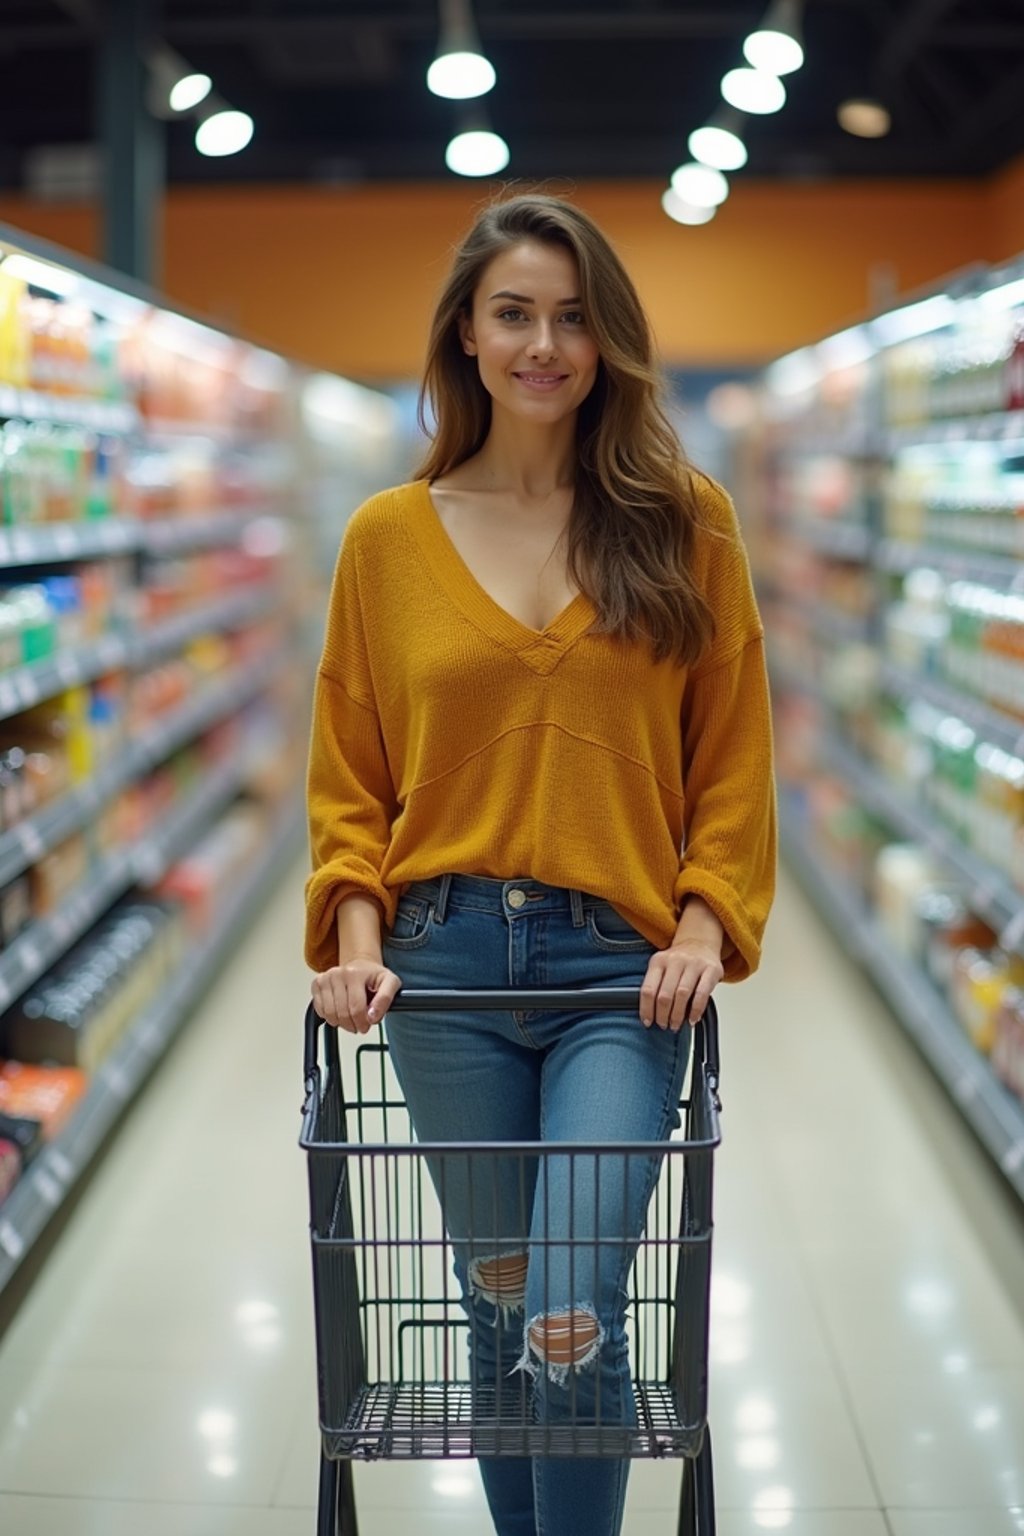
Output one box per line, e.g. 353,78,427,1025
0,582,279,720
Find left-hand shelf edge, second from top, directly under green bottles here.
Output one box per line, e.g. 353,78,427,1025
0,508,269,567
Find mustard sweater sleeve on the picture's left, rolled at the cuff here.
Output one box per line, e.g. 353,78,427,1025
304,522,398,971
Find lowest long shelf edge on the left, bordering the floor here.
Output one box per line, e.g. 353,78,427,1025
0,805,302,1290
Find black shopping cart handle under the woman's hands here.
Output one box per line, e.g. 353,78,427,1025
306,986,722,1109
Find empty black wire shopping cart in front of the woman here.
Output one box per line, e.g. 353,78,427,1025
299,986,722,1536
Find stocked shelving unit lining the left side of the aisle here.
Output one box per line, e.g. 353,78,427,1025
0,216,401,1290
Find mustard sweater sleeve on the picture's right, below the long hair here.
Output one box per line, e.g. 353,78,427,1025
674,487,777,982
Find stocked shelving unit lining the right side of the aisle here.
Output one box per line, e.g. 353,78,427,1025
749,251,1024,1198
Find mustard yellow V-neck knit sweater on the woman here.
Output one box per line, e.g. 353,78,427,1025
306,478,775,982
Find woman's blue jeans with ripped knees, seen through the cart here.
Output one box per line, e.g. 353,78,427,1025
384,874,691,1536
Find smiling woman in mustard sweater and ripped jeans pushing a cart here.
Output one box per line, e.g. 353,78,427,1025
306,195,775,1536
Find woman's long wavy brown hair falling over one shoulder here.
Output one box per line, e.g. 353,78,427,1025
416,194,715,665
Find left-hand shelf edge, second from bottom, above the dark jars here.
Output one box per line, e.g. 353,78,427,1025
0,724,276,1009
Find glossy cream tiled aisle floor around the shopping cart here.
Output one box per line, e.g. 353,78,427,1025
0,868,1024,1536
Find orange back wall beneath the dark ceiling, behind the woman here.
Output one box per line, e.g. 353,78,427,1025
0,161,1024,379
